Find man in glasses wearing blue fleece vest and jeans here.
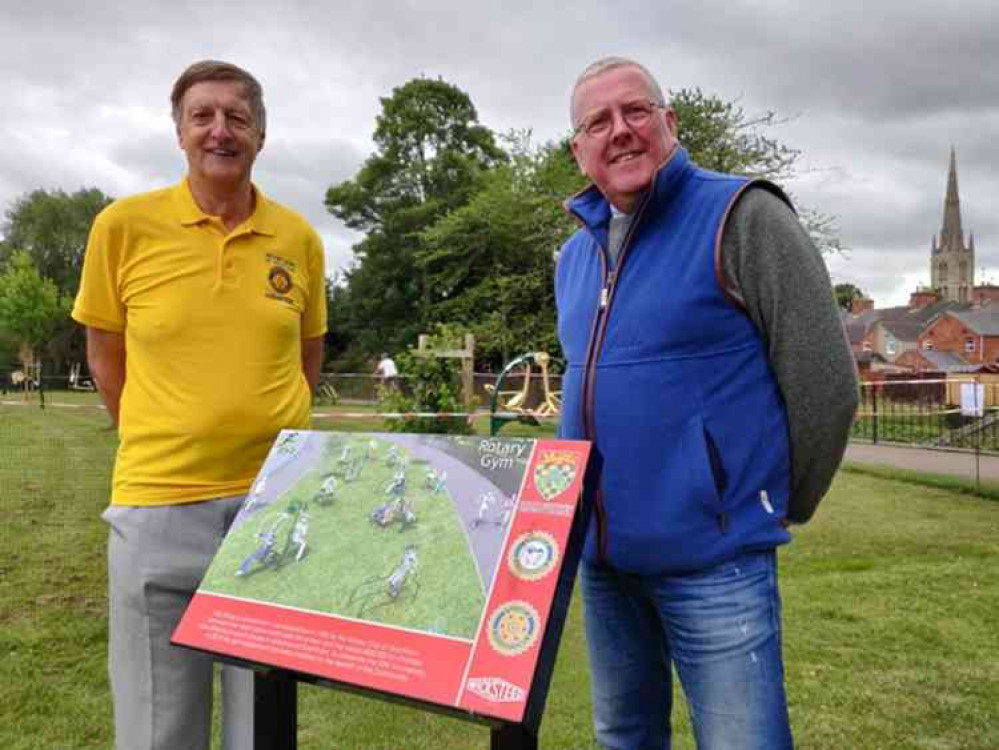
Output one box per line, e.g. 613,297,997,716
555,58,857,750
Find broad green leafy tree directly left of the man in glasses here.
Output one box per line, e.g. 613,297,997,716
418,131,585,371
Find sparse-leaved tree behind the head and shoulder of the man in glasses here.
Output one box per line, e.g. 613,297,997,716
669,88,846,253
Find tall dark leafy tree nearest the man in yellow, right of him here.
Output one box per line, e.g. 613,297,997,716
326,78,505,352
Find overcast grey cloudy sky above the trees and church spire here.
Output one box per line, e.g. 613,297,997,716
0,0,999,306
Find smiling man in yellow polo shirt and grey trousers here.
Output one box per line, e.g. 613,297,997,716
73,61,326,750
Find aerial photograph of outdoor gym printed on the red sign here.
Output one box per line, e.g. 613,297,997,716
200,431,548,639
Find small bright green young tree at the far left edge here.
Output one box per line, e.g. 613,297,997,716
0,251,71,368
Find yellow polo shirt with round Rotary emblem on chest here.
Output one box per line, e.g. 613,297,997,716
72,179,326,505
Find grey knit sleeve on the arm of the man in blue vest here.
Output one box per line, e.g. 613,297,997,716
721,187,857,523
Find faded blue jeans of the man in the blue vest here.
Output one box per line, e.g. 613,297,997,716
580,551,793,750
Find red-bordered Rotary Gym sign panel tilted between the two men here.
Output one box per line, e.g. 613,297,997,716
173,430,589,722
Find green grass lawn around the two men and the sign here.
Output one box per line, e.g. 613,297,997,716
0,408,999,750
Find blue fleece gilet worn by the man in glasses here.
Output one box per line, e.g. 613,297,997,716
555,148,790,574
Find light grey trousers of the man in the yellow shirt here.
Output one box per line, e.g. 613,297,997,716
103,496,253,750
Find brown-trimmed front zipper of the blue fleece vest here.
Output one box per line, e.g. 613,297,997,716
577,191,652,563
